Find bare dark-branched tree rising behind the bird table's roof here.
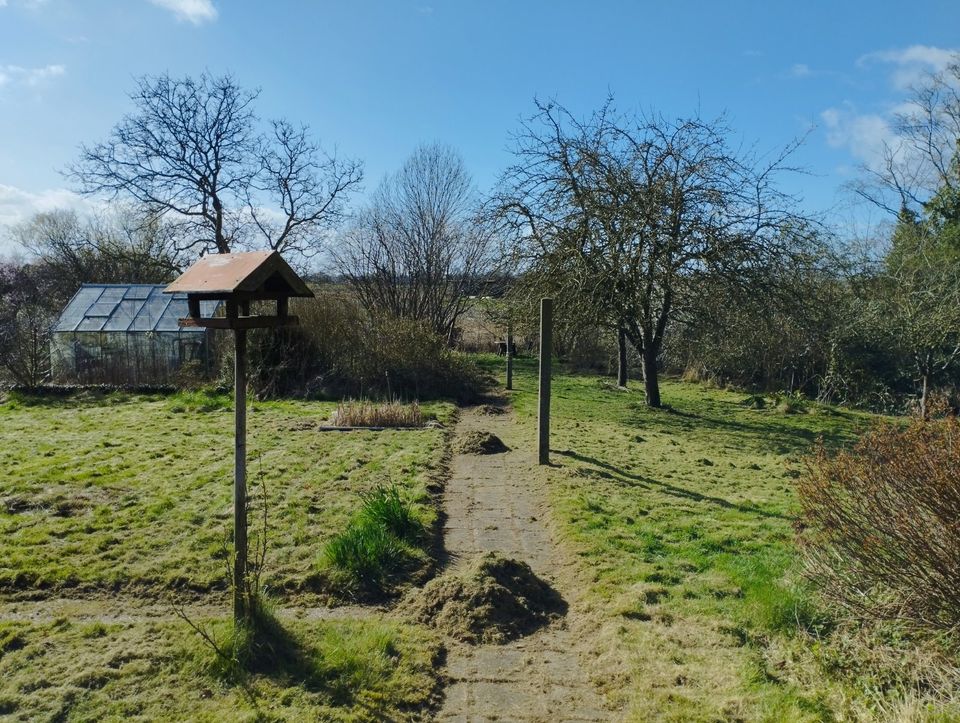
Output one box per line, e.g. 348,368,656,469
68,74,363,256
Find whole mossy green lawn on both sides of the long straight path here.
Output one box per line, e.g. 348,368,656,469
0,370,960,721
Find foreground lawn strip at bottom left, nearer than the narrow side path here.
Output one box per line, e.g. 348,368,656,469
0,620,439,721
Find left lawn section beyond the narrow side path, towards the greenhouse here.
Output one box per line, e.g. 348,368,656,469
0,393,453,594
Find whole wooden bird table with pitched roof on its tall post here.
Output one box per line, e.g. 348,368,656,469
165,251,313,623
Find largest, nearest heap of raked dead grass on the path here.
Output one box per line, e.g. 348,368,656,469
399,552,567,644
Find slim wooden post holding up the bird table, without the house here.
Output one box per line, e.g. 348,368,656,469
233,329,248,624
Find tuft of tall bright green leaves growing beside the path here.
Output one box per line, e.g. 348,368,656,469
323,485,425,593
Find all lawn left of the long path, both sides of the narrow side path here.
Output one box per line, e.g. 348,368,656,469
0,393,453,721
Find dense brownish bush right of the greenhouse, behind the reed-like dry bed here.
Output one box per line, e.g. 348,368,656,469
244,290,484,400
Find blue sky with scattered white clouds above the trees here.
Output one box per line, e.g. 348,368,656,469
0,0,960,252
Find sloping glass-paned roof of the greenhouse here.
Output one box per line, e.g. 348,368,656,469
53,284,221,334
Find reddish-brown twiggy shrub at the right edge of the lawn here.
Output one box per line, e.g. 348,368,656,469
799,417,960,629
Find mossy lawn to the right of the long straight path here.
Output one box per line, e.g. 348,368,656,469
485,359,960,721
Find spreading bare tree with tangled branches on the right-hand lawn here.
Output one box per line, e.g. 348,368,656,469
495,100,808,407
